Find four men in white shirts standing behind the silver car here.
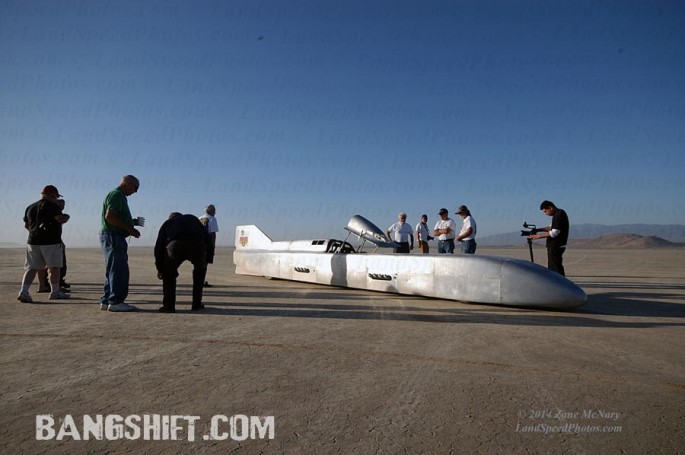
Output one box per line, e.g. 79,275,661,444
386,205,477,254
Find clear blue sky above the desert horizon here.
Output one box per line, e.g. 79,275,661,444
0,0,685,246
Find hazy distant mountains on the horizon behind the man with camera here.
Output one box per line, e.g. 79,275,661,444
477,224,685,248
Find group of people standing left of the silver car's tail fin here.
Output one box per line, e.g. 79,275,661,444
17,175,219,313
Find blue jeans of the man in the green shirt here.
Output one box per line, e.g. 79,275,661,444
100,231,129,305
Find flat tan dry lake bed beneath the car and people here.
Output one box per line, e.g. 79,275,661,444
0,247,685,454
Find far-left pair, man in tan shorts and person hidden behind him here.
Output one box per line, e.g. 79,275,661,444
17,185,69,303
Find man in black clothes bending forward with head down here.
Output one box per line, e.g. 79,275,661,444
155,212,209,313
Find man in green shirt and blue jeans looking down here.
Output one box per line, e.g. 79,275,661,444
100,175,145,311
